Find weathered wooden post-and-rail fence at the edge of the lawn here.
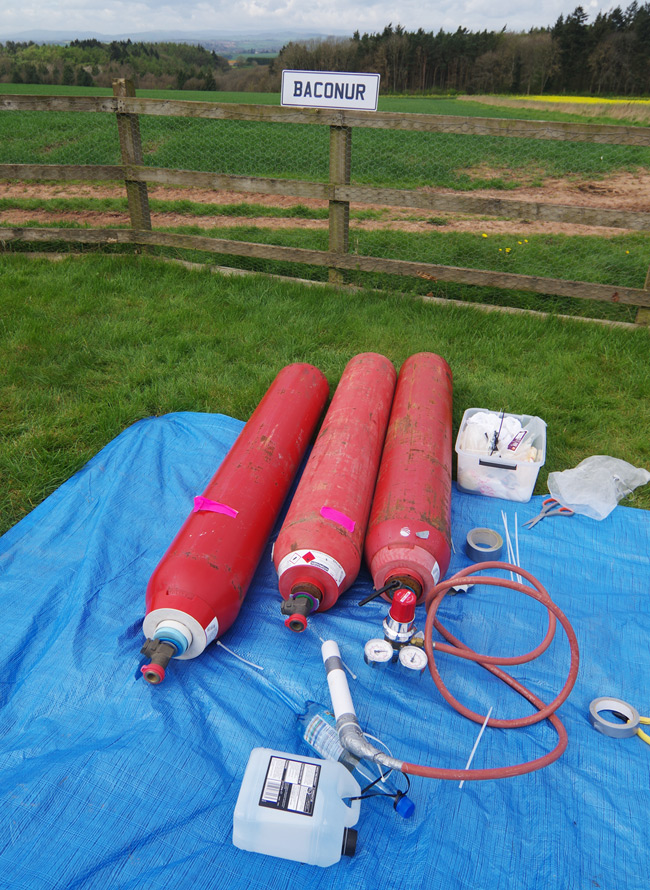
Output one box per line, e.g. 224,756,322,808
0,80,650,324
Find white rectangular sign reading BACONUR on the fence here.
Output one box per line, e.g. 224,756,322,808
282,71,379,111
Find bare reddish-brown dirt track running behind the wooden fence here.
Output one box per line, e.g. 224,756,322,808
0,170,650,236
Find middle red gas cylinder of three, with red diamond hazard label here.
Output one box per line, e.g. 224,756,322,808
273,352,397,631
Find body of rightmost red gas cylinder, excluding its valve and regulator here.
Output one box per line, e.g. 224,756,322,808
365,352,452,602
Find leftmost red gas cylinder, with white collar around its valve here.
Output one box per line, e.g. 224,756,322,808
142,364,329,683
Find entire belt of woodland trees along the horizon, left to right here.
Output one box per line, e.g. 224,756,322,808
0,0,650,96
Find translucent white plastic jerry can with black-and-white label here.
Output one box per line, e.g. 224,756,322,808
232,748,361,866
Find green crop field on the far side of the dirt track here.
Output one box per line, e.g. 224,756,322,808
0,84,650,190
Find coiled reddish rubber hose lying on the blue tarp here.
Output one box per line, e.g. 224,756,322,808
402,562,580,781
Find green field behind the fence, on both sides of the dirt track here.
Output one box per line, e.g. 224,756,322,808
0,84,650,321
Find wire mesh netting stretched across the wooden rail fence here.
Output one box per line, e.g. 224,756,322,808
0,88,650,319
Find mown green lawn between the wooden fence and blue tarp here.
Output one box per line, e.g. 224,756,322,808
0,254,650,531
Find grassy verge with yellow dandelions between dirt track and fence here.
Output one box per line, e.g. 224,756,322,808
0,198,650,322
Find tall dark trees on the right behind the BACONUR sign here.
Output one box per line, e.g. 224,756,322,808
276,2,650,95
